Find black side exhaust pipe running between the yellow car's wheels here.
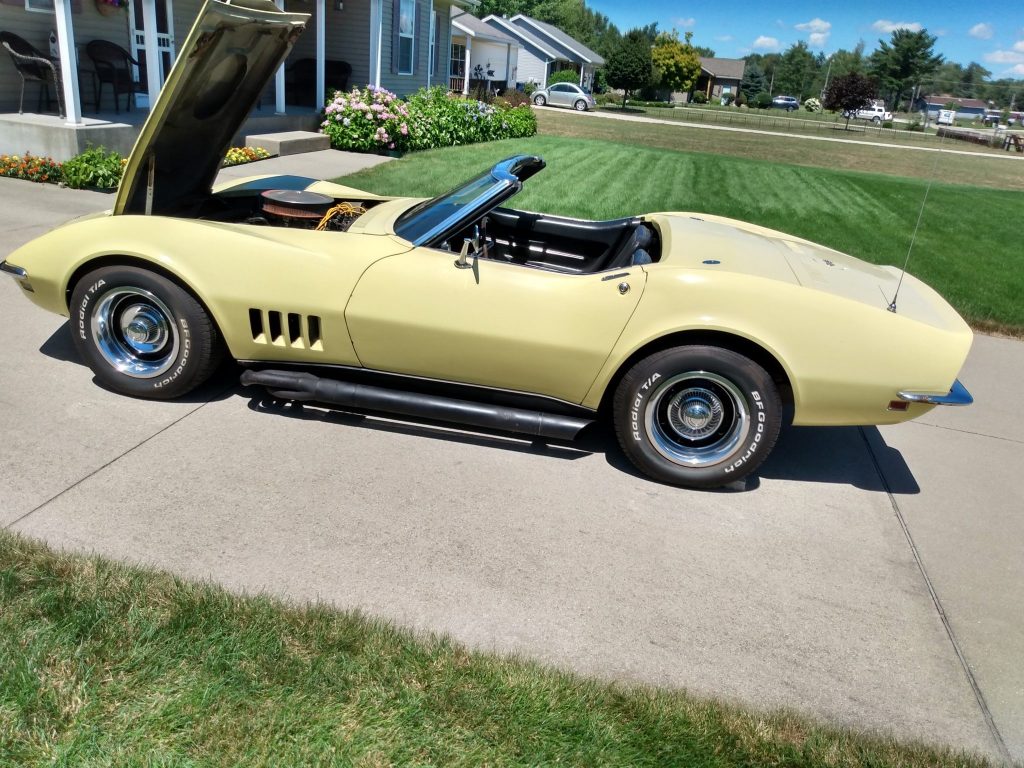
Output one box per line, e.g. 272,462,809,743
242,371,593,440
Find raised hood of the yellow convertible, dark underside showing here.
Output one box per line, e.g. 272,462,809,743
114,0,309,215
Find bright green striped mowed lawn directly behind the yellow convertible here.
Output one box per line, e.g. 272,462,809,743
343,135,1024,333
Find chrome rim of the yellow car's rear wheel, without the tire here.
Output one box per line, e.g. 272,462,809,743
644,371,751,467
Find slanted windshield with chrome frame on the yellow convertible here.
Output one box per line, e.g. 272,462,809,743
394,155,545,247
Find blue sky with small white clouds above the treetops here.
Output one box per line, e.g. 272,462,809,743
587,0,1024,78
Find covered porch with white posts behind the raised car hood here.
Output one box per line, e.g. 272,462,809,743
0,0,352,161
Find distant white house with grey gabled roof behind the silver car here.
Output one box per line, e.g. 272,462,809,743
483,13,604,89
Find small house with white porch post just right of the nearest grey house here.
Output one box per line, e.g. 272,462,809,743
449,6,519,93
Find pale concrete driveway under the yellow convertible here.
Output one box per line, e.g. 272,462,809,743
0,159,1024,760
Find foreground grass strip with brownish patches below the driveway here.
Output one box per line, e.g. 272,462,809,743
0,531,988,768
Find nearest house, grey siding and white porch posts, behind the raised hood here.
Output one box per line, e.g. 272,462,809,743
0,0,477,160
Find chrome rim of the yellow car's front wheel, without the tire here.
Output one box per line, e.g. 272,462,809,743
90,286,180,379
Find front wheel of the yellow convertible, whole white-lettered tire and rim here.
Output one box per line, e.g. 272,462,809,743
70,266,222,399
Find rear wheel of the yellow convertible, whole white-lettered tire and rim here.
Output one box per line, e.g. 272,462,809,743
613,346,782,488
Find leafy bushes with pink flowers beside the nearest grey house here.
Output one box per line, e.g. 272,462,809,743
321,86,537,152
